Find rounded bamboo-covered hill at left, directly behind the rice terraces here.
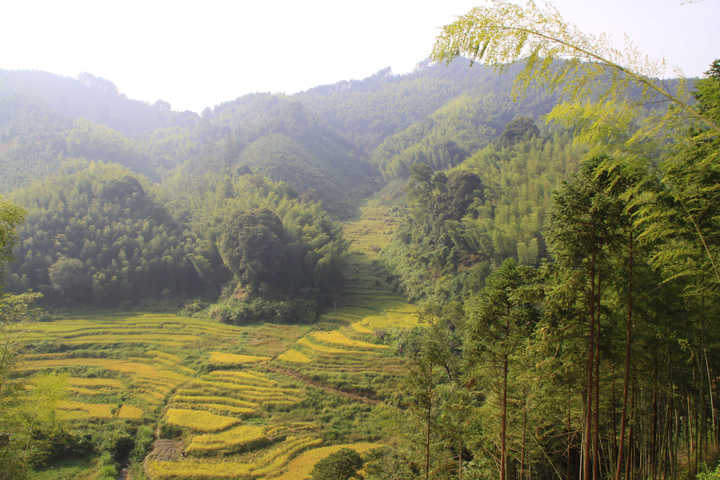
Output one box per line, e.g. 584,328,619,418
9,164,202,303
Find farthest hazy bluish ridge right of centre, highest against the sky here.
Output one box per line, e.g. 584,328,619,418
295,58,552,158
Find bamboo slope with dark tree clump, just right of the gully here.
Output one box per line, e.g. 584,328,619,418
384,124,585,301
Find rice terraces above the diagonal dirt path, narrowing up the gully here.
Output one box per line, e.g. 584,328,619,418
271,202,418,397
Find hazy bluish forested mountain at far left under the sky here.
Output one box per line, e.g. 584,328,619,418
0,70,199,192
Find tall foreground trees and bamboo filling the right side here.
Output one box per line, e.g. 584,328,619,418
376,2,720,480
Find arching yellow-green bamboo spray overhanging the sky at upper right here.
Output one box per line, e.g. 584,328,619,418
433,1,720,282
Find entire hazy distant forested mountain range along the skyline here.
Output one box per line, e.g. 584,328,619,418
0,60,552,217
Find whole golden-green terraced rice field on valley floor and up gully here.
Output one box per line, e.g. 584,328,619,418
20,203,417,480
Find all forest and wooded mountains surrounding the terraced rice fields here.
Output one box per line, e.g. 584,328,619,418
0,5,720,480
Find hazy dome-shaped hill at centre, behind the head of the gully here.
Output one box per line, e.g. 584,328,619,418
181,94,379,216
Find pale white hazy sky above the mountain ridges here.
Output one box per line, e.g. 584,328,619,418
0,0,720,111
